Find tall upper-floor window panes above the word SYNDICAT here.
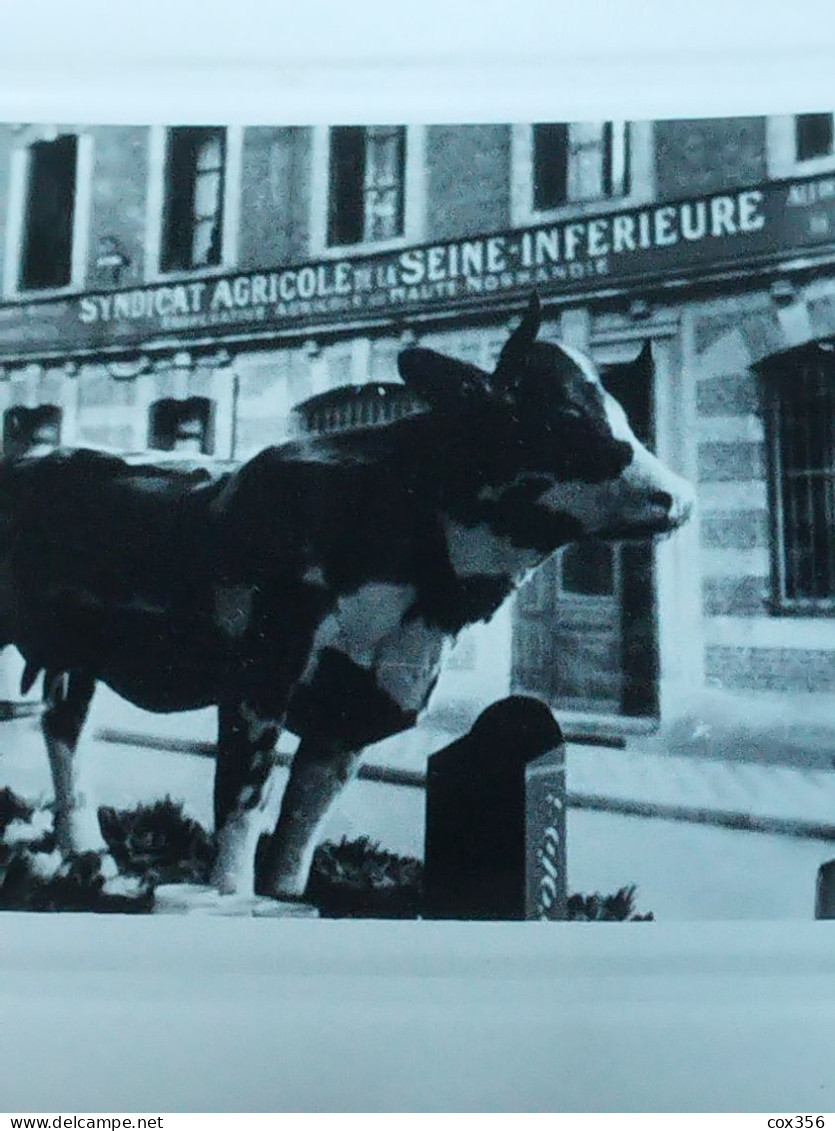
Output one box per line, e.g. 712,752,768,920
161,127,226,271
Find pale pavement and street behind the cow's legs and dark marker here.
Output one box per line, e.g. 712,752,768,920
0,678,835,921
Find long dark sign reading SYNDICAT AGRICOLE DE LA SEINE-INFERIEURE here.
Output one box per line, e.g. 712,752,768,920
0,175,835,357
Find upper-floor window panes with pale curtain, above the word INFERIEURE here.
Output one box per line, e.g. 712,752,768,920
532,122,630,211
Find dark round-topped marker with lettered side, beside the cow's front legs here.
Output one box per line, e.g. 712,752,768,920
424,696,567,920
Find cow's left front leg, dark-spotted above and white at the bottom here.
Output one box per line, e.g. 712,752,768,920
212,702,278,896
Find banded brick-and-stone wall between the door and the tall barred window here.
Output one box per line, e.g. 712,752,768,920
692,294,835,692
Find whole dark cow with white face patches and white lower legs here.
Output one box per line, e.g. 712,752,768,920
0,295,694,901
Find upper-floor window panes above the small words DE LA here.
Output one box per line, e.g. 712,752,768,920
327,126,406,247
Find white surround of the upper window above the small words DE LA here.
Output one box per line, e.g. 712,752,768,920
309,122,425,259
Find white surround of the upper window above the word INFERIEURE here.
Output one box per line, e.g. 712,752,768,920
510,120,655,227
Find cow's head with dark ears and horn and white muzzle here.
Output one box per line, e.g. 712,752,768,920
399,295,695,538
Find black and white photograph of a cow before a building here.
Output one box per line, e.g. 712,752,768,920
0,106,835,930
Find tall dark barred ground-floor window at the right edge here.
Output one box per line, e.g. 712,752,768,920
764,343,835,612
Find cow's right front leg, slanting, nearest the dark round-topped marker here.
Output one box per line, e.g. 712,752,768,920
259,739,362,899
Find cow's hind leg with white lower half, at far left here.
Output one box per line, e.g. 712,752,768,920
41,671,117,879
